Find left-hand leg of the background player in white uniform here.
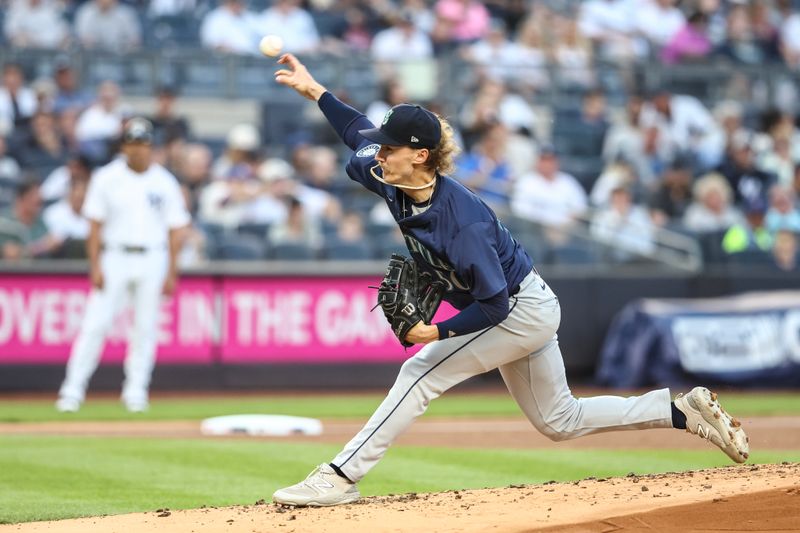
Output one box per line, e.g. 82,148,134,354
56,257,126,412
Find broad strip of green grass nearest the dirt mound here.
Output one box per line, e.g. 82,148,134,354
0,436,800,523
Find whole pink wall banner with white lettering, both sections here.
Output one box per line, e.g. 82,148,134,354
0,275,454,364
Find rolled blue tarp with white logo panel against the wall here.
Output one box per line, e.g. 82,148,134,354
598,291,800,388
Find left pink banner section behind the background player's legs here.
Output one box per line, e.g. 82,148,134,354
0,275,217,364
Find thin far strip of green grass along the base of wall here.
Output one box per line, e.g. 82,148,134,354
0,392,800,422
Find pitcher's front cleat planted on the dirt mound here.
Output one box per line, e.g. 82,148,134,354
272,464,361,507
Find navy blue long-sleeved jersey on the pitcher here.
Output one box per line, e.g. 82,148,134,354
319,93,533,338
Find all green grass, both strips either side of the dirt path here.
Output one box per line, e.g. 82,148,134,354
0,394,800,523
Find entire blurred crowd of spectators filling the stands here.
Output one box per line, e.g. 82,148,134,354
0,0,800,271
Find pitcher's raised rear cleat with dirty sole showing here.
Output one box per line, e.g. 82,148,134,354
675,387,750,463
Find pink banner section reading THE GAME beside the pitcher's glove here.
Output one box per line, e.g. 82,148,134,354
222,277,455,363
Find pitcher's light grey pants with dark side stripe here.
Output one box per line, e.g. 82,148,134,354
332,272,672,481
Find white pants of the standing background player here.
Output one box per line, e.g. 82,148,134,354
59,248,169,402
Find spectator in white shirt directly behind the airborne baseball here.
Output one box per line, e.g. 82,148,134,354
258,0,320,54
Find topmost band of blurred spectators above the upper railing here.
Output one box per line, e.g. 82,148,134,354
0,0,800,67
